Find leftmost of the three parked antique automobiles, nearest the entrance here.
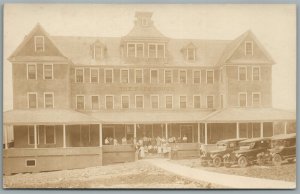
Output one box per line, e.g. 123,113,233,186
200,138,245,167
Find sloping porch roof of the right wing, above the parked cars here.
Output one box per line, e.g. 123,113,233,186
203,108,296,123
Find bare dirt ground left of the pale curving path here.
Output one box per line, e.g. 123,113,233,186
3,160,222,189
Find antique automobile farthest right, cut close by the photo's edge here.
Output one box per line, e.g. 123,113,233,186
257,133,296,166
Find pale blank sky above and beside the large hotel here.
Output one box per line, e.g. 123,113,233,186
3,4,296,111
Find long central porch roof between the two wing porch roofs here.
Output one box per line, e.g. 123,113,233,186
88,111,212,124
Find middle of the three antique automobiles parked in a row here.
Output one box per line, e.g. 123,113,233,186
223,138,271,168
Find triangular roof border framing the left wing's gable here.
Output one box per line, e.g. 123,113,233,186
8,23,67,61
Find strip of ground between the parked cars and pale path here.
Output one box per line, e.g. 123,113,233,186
171,159,296,182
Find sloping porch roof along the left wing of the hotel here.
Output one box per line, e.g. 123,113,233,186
3,109,96,125
